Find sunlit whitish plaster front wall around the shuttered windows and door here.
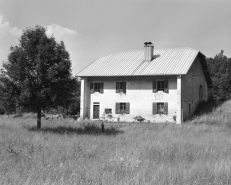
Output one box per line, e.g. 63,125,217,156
85,76,177,122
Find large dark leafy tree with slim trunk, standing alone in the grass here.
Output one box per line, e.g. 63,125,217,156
0,26,76,128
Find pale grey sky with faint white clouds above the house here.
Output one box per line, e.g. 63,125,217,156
0,0,231,76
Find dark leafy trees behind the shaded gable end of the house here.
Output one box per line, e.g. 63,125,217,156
207,51,231,100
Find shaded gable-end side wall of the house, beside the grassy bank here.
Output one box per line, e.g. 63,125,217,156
182,57,208,120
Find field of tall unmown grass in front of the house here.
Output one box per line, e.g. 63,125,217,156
0,101,231,185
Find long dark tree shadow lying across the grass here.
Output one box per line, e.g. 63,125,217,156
27,125,124,136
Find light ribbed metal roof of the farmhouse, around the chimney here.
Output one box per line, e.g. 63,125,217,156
76,48,199,77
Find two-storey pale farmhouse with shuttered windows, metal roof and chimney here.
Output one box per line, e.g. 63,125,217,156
77,42,212,124
